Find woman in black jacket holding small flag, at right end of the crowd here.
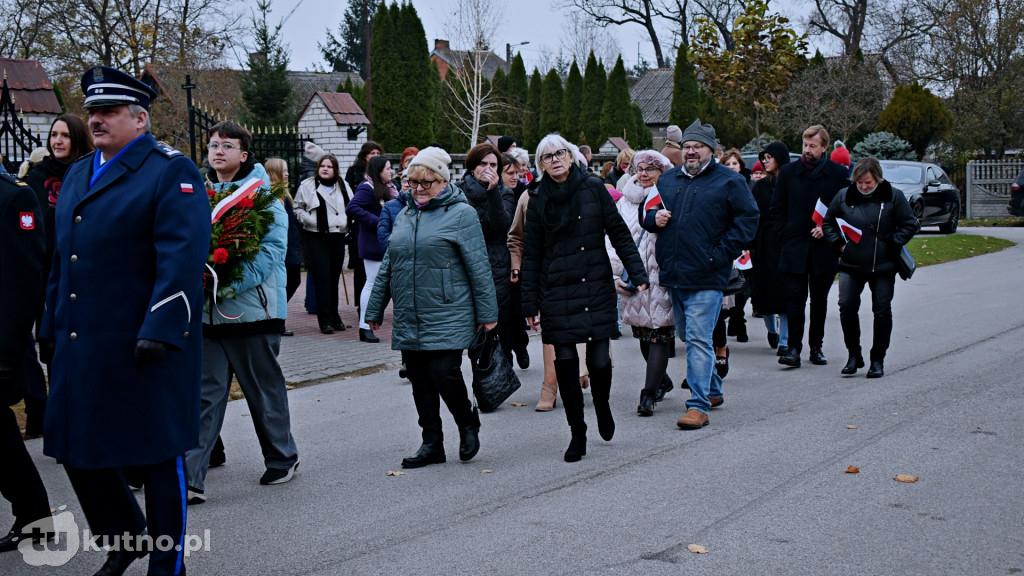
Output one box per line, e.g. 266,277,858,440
821,157,919,378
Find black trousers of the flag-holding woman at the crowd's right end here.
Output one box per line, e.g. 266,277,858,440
839,272,896,362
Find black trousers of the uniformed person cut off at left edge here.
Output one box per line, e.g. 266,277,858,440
0,406,50,535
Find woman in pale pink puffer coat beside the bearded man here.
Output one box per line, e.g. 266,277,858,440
605,150,676,416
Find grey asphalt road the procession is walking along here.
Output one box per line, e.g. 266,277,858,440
0,229,1024,576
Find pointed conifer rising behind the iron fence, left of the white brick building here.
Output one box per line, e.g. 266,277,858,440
241,0,296,126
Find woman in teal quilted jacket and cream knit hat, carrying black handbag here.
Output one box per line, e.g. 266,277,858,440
366,147,498,468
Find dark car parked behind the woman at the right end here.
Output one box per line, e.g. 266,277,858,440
880,160,961,234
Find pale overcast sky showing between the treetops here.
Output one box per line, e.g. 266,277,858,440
262,0,815,74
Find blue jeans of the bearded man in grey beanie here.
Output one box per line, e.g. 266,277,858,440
670,289,722,414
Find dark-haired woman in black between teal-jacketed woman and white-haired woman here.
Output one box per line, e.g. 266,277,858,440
457,142,518,362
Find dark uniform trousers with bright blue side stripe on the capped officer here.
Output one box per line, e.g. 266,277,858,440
65,456,185,575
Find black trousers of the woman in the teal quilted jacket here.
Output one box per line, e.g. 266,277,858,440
401,349,476,444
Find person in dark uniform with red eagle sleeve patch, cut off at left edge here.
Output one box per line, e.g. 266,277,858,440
0,168,52,552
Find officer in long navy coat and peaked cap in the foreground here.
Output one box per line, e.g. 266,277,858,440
40,67,210,576
